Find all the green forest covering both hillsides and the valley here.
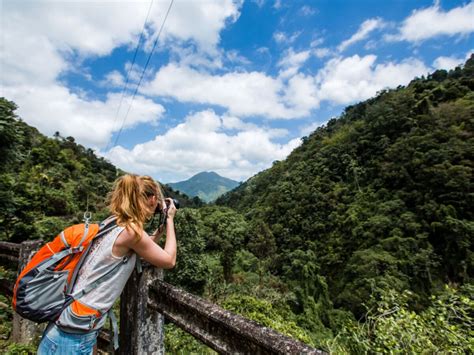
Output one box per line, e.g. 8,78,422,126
0,56,474,354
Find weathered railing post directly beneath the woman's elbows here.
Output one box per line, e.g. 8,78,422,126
118,262,164,355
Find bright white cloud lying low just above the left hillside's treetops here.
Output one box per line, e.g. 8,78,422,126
1,85,165,148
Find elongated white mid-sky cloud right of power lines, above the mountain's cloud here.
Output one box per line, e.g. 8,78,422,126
141,63,309,118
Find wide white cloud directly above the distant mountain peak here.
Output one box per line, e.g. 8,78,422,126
107,110,300,182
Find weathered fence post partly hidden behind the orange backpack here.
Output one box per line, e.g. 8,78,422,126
12,240,43,344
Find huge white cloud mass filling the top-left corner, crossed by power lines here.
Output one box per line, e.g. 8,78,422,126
0,0,241,147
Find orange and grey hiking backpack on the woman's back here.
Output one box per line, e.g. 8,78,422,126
13,219,116,323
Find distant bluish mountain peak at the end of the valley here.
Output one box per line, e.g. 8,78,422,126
167,171,239,202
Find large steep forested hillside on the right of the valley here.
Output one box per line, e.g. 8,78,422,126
216,56,474,317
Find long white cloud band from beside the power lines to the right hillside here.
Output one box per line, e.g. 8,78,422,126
141,49,436,119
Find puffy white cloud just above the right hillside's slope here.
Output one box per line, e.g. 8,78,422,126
316,55,429,104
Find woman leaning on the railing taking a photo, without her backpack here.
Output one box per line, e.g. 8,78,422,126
38,175,176,355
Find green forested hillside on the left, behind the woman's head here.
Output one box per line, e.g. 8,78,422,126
0,98,202,242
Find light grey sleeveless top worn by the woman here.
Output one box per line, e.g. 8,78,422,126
72,227,137,313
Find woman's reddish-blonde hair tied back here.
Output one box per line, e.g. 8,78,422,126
108,174,163,239
